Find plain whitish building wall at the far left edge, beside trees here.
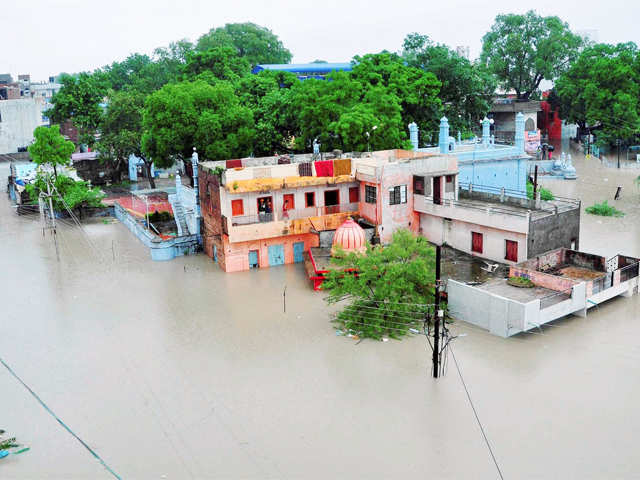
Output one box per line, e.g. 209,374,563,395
0,98,42,154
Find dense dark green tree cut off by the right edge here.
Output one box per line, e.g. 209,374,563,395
553,43,640,145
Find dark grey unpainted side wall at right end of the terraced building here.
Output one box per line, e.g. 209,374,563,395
527,207,580,257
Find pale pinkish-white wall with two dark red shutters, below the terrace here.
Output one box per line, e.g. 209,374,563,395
420,214,527,263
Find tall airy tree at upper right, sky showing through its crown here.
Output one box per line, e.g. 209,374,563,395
480,10,583,99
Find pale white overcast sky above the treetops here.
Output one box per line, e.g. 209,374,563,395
5,0,640,80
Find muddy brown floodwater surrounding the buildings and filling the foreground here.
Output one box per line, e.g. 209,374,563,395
0,151,640,479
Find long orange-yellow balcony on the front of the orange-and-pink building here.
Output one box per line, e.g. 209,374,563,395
222,203,358,242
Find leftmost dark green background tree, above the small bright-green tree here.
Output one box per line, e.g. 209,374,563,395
45,73,106,145
